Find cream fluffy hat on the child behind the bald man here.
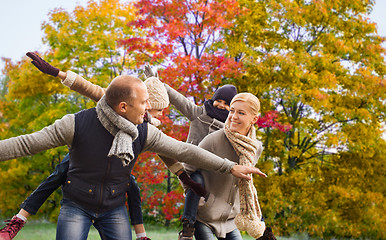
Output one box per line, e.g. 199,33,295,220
145,77,169,109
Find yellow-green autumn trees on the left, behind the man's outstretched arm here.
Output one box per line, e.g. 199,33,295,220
0,0,137,220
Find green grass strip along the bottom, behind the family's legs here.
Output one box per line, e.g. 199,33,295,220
6,221,308,240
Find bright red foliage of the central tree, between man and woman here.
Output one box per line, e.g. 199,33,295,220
120,0,243,223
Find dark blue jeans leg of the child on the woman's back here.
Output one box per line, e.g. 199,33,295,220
182,171,205,223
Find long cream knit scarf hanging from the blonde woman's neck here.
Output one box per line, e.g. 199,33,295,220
224,120,265,238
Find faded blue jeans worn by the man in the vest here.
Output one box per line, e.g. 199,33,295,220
56,199,131,240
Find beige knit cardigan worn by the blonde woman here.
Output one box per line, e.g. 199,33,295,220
185,129,262,238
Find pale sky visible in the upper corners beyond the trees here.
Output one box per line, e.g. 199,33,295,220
0,0,386,74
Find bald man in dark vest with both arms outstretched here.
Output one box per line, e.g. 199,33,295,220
0,76,262,240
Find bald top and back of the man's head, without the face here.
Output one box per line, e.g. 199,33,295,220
105,75,143,108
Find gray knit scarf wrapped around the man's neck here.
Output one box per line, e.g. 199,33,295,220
96,96,138,167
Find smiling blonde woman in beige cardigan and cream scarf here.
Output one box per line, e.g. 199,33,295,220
185,93,272,240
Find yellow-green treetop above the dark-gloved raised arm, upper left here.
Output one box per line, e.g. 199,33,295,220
42,0,137,86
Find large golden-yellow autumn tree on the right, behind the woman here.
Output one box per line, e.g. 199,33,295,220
227,0,386,239
